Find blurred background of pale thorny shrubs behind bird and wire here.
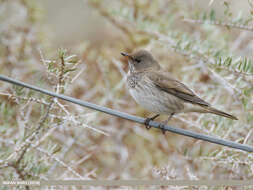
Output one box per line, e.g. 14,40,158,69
0,0,253,189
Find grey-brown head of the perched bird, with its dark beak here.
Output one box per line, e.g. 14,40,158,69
121,50,160,72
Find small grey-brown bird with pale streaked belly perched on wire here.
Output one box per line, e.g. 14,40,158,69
121,50,238,133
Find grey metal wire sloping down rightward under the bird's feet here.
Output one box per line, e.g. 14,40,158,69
0,75,253,152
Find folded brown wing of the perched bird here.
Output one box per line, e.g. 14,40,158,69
146,71,210,106
